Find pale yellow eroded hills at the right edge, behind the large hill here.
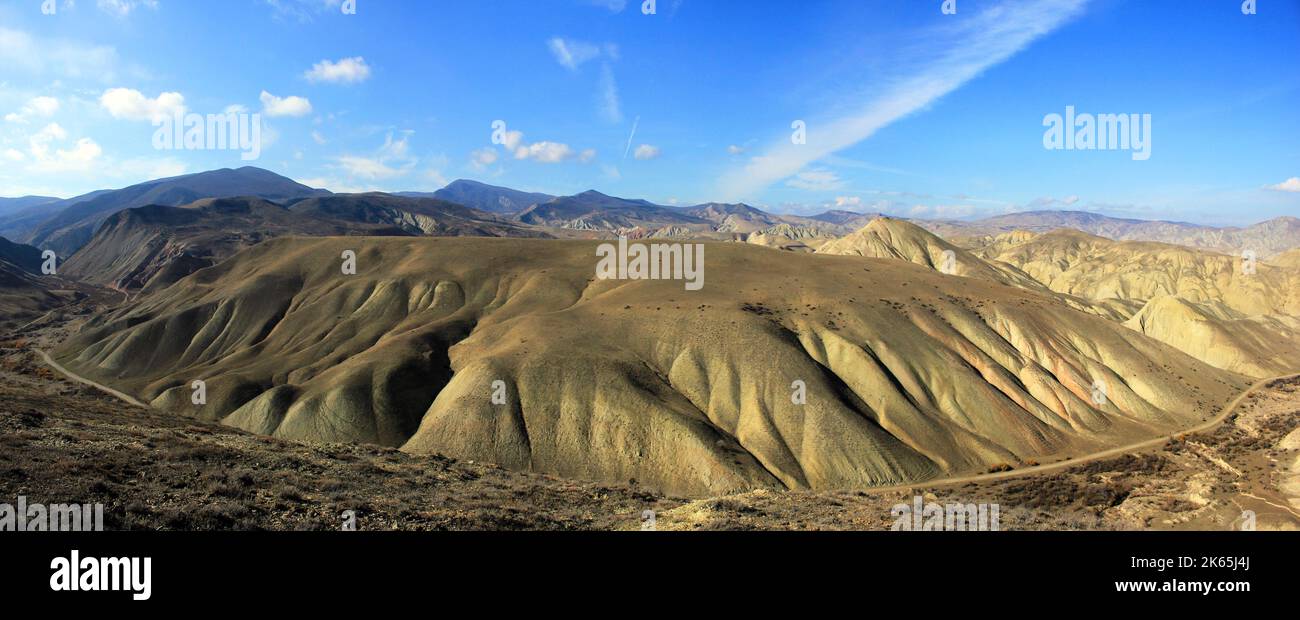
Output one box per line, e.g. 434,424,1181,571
979,230,1300,377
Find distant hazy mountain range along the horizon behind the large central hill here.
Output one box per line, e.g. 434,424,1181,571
0,168,1300,259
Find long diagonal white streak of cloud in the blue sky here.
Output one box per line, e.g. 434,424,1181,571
719,0,1087,200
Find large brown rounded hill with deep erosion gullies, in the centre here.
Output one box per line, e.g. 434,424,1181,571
57,238,1247,494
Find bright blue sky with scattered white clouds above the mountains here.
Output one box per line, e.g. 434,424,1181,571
0,0,1300,225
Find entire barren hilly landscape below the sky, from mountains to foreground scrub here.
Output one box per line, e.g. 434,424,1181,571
0,169,1300,529
